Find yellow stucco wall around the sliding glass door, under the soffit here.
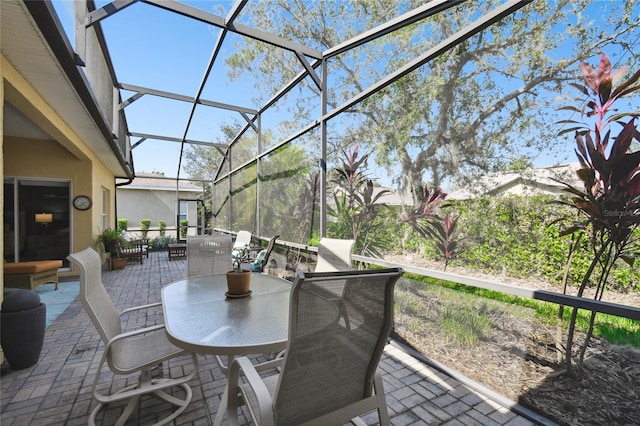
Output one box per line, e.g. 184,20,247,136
0,57,115,278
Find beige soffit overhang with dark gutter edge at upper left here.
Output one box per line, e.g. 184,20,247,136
0,0,133,177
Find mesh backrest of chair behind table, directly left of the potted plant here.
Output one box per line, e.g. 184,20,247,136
187,235,232,277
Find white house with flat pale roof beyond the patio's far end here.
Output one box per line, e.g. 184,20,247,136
116,173,203,237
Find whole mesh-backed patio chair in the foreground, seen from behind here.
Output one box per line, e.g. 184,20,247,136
223,268,403,426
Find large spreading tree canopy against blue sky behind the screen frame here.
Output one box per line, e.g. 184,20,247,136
201,0,640,205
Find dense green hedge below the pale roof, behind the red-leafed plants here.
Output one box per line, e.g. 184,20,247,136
392,196,640,290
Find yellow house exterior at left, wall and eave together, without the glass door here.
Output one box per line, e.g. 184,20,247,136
0,0,134,286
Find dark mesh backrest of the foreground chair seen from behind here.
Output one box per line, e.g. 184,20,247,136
273,268,403,425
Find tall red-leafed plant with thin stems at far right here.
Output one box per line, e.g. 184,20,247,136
559,53,640,371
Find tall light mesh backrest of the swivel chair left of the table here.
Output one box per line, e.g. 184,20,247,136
67,247,122,343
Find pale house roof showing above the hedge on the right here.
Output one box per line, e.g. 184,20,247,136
447,163,581,200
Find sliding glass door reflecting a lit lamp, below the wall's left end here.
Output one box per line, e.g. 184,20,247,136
4,178,71,267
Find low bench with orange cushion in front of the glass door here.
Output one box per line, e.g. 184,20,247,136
4,260,62,290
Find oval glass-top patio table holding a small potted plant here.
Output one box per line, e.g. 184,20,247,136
162,273,291,356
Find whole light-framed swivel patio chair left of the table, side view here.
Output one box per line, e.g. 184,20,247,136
68,248,198,425
